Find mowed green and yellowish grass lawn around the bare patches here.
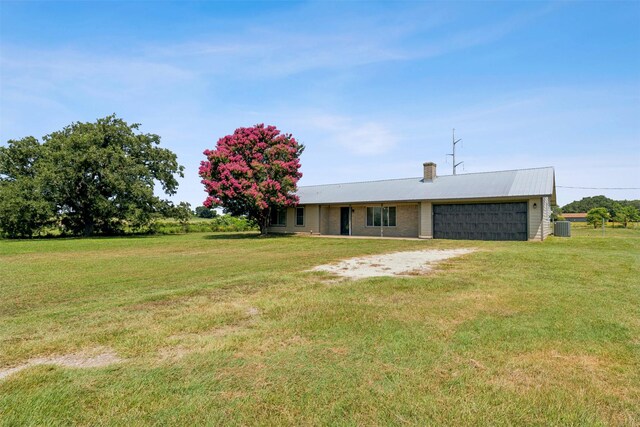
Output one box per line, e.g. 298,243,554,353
0,227,640,425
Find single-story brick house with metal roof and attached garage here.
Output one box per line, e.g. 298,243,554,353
269,162,556,240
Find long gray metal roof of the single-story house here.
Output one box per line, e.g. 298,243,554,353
296,167,555,204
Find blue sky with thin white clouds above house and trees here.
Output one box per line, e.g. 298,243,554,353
0,0,640,207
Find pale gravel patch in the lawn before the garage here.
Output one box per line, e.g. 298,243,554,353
311,249,475,280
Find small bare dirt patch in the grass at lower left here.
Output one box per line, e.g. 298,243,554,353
0,349,122,380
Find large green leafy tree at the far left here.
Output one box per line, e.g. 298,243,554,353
0,115,183,237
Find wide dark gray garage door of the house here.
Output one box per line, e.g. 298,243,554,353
433,202,527,240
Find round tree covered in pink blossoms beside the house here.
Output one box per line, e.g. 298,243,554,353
200,124,304,235
